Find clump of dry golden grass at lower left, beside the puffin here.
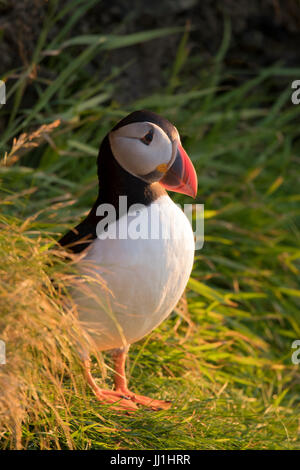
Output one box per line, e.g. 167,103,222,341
0,218,104,449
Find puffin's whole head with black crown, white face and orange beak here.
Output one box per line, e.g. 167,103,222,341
98,110,197,205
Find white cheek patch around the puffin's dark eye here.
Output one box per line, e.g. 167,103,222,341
109,122,179,181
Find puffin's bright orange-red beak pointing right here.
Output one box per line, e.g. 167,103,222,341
159,142,198,198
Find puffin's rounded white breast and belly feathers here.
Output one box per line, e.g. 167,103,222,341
74,196,195,350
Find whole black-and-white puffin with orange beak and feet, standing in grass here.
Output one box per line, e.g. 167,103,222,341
59,110,197,411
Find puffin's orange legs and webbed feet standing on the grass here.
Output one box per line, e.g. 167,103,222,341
84,349,171,411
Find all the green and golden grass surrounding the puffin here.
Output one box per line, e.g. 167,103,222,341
0,0,300,449
